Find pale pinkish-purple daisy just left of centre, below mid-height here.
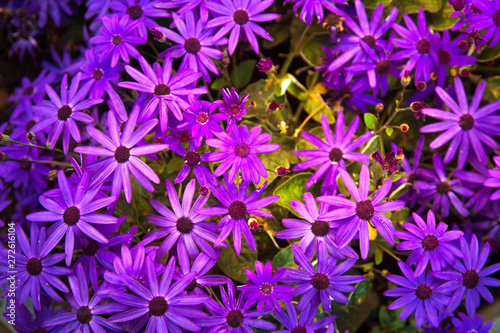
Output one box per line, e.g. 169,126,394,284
146,179,217,265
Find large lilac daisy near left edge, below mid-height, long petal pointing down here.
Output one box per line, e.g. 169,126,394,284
26,170,117,266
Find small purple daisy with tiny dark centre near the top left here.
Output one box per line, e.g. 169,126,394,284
89,14,146,68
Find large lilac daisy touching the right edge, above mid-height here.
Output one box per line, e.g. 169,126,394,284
420,76,500,169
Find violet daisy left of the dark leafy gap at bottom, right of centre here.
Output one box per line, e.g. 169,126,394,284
281,241,365,312
